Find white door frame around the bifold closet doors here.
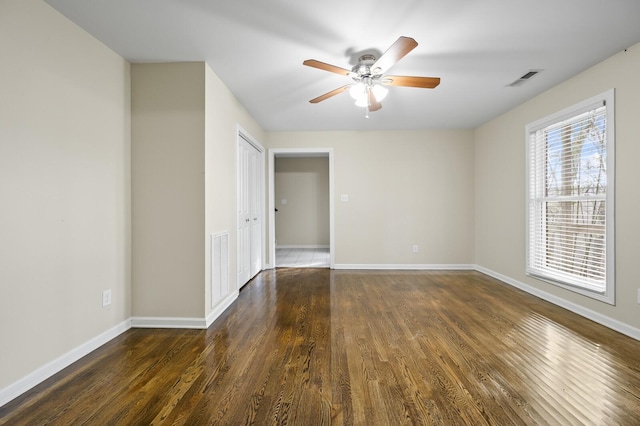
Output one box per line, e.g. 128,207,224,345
234,124,266,289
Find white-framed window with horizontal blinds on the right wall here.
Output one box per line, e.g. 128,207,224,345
526,90,615,304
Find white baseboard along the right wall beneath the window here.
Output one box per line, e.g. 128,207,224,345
475,265,640,340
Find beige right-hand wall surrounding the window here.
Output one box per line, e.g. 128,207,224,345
475,45,640,329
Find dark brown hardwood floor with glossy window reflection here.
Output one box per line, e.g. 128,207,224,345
0,269,640,425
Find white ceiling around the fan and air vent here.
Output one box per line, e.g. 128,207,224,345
47,0,640,131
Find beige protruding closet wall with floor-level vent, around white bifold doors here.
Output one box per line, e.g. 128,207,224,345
131,62,263,319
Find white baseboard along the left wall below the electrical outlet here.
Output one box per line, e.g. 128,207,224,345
0,320,131,407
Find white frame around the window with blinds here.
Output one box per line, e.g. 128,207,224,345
525,89,615,305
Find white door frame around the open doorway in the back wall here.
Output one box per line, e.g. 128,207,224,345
267,148,335,269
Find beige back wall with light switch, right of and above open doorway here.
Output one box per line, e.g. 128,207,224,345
267,130,474,265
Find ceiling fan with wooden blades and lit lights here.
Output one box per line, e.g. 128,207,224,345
302,37,440,118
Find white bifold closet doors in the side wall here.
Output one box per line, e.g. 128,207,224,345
237,138,262,287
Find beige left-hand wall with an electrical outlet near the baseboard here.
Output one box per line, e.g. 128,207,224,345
0,0,131,389
